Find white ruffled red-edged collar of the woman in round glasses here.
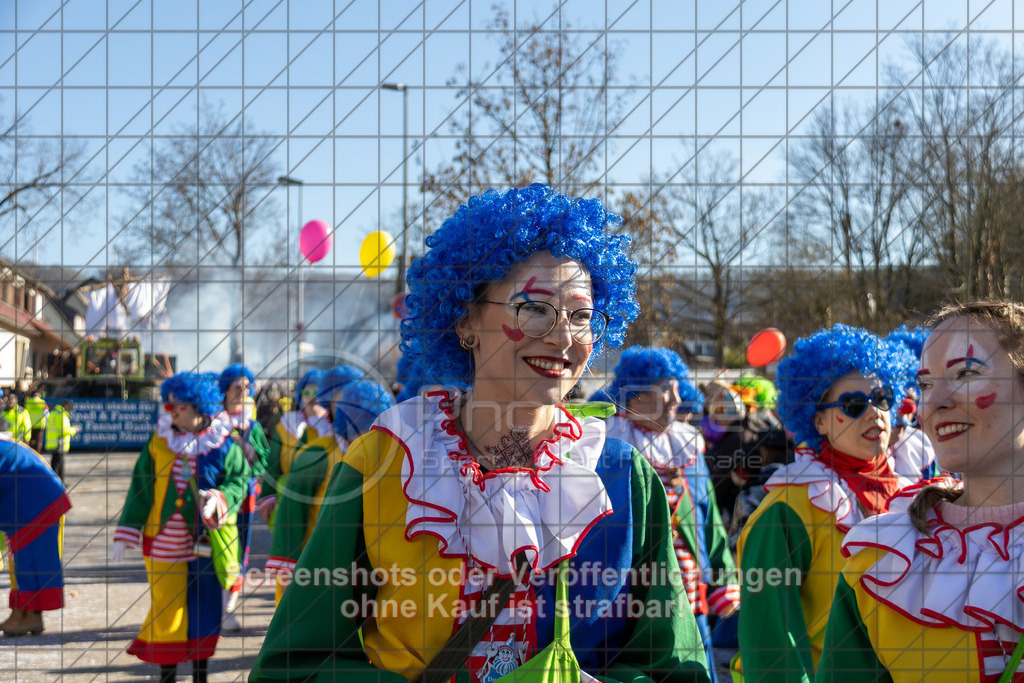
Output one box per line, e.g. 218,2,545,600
374,391,611,577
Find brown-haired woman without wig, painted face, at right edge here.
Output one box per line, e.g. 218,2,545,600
817,301,1024,683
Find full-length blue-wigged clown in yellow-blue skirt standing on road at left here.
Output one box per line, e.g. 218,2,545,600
111,373,250,681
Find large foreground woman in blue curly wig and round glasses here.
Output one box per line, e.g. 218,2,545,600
250,184,708,683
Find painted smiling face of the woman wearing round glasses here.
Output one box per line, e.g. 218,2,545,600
459,252,594,405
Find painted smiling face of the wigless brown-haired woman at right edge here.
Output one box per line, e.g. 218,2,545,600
918,317,1024,477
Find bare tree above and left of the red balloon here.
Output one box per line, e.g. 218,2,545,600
623,150,779,366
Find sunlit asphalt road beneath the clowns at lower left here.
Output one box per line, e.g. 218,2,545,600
0,453,273,683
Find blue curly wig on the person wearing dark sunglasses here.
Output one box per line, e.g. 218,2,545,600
775,325,918,449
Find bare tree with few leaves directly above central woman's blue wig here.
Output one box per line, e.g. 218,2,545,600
423,6,623,222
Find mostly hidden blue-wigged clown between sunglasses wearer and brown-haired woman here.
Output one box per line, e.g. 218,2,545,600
886,325,939,481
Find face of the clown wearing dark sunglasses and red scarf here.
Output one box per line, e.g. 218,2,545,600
814,373,892,461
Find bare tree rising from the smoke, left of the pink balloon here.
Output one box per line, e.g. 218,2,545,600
119,106,280,361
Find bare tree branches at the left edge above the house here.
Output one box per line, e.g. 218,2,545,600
0,108,85,256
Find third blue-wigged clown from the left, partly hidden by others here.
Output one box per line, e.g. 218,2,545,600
256,369,332,527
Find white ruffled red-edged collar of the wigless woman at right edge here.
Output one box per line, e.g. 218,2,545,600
843,479,1024,633
